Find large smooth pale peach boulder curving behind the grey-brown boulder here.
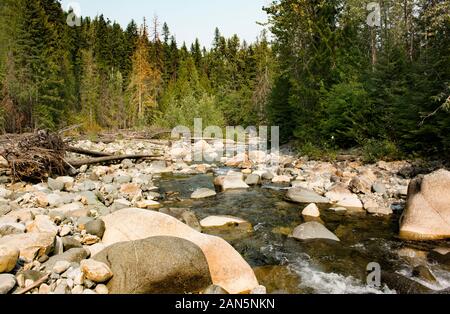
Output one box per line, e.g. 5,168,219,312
102,208,258,293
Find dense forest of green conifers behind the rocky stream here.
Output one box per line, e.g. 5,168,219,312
0,0,450,159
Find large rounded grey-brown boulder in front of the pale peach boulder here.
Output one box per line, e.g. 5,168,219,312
94,237,212,294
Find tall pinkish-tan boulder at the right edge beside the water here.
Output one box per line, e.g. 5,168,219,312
400,170,450,241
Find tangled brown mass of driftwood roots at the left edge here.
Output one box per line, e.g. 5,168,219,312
0,131,66,181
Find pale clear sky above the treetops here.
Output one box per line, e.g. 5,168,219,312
61,0,271,47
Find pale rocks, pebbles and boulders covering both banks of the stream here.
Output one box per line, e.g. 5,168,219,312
0,140,450,294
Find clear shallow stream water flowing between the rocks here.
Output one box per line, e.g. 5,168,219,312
159,168,450,294
